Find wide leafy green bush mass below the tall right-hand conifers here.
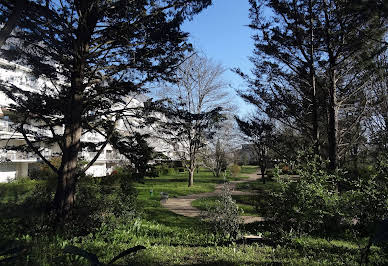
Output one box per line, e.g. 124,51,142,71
258,154,388,241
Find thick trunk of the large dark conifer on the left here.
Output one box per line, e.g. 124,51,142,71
54,1,97,221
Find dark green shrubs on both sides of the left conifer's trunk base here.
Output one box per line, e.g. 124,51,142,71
0,176,137,239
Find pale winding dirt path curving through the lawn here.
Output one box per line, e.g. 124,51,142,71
160,173,264,224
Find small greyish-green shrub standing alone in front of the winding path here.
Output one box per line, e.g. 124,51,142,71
202,183,242,240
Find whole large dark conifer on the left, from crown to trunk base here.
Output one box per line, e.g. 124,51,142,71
0,0,211,221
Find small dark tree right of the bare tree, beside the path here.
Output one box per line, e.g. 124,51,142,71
236,117,274,183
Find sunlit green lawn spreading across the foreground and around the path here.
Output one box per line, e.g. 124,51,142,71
0,167,384,265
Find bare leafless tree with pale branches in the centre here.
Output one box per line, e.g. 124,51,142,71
162,54,228,187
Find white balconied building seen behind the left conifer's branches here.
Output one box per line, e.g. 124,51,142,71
0,59,173,182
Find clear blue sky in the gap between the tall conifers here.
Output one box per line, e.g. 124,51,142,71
183,0,253,116
